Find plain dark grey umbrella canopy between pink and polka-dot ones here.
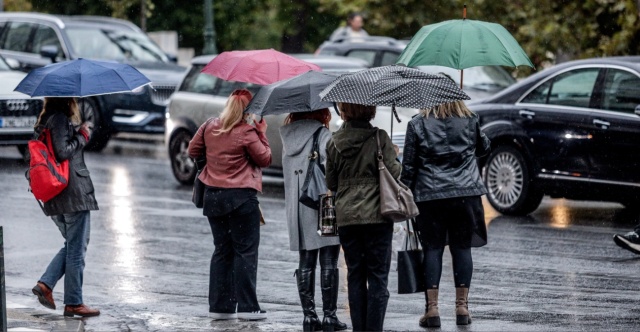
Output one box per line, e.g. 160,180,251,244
245,70,338,115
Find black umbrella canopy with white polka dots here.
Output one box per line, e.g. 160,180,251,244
320,65,470,109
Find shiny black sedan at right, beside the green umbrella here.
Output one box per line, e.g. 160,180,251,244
469,56,640,215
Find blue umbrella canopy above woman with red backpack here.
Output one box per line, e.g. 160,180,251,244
14,59,151,97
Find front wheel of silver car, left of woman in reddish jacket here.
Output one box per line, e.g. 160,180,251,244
169,130,196,184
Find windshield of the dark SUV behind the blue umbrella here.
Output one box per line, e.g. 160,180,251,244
67,27,167,62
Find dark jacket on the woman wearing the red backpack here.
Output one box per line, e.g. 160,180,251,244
36,112,98,216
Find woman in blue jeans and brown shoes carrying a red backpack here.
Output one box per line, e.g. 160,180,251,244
32,97,100,317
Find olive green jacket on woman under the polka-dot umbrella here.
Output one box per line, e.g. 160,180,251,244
326,121,402,227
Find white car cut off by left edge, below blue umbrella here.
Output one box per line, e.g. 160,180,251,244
0,55,42,155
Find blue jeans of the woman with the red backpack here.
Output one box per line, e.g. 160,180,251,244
40,211,91,305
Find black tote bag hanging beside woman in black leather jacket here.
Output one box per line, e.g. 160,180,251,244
397,219,426,294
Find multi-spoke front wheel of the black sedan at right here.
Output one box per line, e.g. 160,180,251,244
484,146,543,215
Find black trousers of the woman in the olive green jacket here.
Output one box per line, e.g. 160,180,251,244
339,223,393,331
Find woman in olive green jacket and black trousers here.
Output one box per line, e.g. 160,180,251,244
326,103,401,331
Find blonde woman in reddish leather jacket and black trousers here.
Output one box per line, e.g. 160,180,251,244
188,89,271,320
